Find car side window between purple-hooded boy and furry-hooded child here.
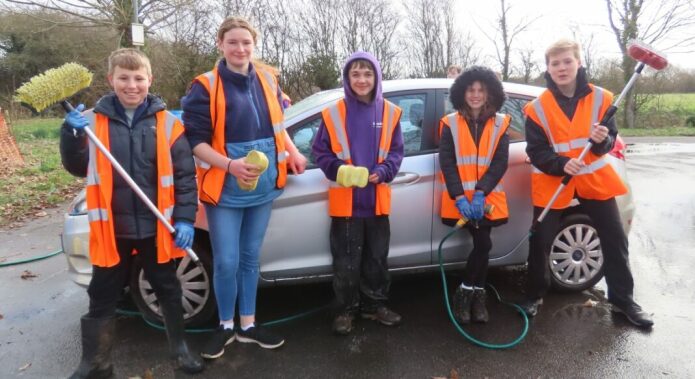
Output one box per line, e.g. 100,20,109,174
387,93,427,157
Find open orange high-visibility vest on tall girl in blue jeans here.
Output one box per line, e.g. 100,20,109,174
194,65,287,204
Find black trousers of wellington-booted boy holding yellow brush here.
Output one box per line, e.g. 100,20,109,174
87,237,181,318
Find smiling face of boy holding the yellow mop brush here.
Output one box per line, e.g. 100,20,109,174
108,66,152,108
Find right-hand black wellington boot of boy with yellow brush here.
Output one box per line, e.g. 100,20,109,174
160,300,205,374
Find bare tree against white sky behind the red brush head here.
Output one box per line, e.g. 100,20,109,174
606,0,695,128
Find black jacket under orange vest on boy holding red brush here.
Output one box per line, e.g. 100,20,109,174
526,67,618,176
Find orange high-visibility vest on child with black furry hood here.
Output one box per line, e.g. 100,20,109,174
439,112,512,220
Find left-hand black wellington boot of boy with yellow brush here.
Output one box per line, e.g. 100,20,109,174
70,316,116,379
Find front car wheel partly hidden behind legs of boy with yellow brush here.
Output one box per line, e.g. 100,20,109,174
130,239,217,327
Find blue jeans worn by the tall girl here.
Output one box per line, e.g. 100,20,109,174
205,201,273,321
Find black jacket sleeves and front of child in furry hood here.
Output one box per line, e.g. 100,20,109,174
439,113,509,225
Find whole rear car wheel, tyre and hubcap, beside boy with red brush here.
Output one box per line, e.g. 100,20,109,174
548,214,604,291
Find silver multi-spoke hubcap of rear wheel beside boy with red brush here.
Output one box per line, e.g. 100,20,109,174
549,224,603,286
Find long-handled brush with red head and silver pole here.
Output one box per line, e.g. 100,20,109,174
529,40,668,235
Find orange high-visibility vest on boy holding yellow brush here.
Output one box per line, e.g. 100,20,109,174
85,110,185,267
